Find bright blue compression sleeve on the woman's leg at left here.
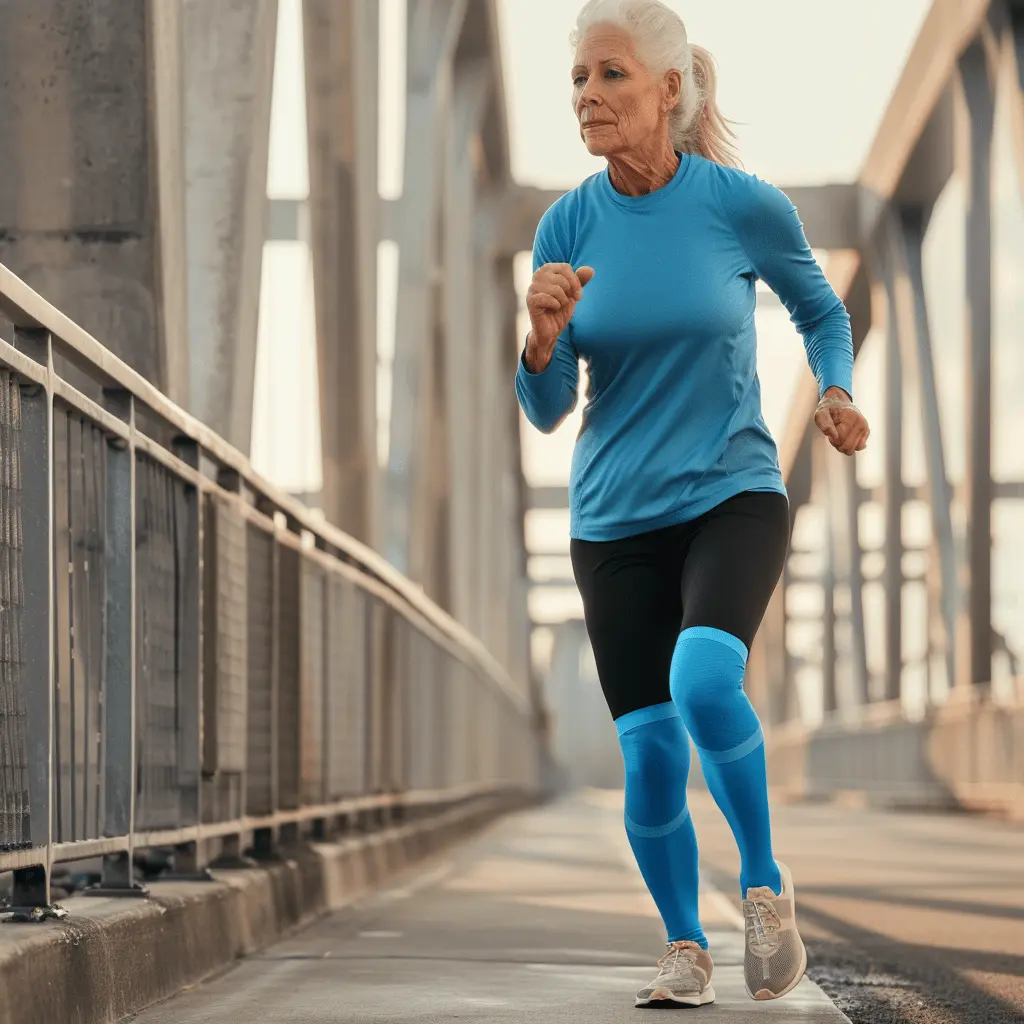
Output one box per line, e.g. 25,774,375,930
615,701,708,949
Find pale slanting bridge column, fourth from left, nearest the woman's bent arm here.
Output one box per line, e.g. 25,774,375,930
384,0,466,584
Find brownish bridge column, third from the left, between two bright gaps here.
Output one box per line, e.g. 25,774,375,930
303,0,385,546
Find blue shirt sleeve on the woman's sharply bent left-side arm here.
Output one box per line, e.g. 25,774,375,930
515,200,580,434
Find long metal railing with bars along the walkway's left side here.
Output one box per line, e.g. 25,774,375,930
0,266,542,906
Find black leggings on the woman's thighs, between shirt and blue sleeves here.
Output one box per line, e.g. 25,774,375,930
569,490,790,718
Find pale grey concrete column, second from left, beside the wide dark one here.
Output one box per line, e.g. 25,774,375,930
184,0,278,454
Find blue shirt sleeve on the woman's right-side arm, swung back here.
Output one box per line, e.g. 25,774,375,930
731,175,853,397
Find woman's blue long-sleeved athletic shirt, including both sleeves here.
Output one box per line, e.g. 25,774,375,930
516,155,853,541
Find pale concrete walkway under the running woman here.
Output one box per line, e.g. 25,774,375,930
134,792,846,1024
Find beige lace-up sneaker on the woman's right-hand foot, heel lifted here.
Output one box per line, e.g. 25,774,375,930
743,861,807,999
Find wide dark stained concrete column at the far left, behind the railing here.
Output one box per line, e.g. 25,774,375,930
0,0,188,403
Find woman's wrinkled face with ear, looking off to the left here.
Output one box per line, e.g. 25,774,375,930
572,25,682,157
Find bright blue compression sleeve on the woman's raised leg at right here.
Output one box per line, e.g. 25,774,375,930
672,626,782,897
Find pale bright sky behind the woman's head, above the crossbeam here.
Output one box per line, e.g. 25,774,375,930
498,0,931,188
